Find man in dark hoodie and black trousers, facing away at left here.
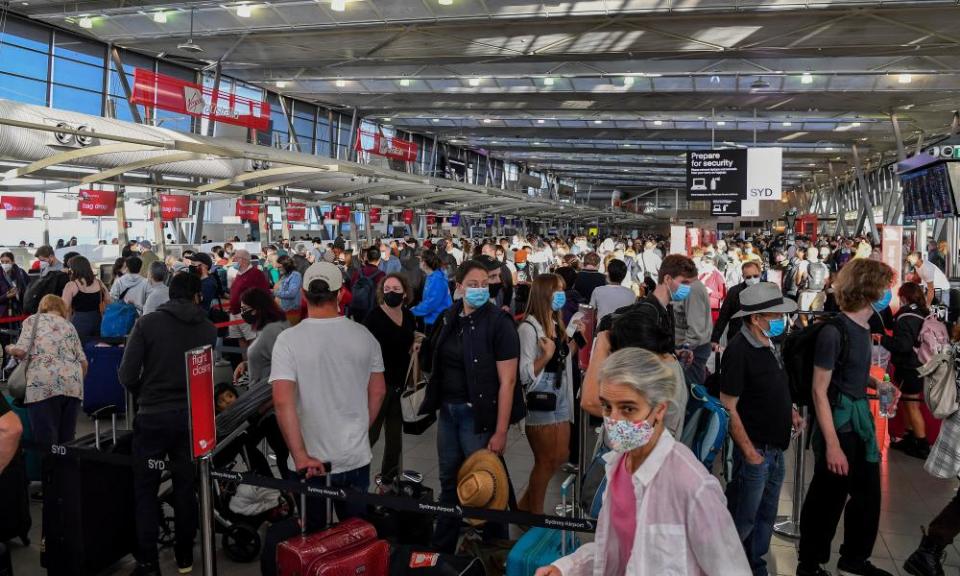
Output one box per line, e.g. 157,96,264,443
120,274,217,576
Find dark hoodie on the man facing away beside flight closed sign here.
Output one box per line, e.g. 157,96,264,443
120,296,217,414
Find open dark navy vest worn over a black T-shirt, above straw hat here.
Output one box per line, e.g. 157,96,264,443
420,300,526,434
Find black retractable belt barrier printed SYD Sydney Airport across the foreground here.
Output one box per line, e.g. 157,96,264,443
21,441,596,533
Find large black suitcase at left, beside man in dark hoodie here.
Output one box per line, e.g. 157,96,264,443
41,407,137,576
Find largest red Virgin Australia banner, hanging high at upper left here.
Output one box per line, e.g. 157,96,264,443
130,68,270,131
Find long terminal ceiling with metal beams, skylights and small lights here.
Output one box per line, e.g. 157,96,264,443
20,0,960,193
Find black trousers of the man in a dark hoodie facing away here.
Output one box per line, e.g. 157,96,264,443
133,410,198,563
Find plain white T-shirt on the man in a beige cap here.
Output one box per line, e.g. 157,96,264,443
270,316,383,473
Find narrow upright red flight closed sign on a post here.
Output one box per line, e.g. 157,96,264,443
184,346,217,458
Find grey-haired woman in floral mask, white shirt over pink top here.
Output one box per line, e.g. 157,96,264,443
536,348,751,576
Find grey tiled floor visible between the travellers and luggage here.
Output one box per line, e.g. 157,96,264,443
13,412,960,576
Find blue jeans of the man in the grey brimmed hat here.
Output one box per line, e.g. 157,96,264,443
727,447,784,576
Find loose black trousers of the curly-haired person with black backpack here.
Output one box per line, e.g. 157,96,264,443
799,432,880,566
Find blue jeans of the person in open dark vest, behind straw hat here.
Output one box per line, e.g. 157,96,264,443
433,403,507,554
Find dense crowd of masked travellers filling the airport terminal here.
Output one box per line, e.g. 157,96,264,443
0,230,960,576
